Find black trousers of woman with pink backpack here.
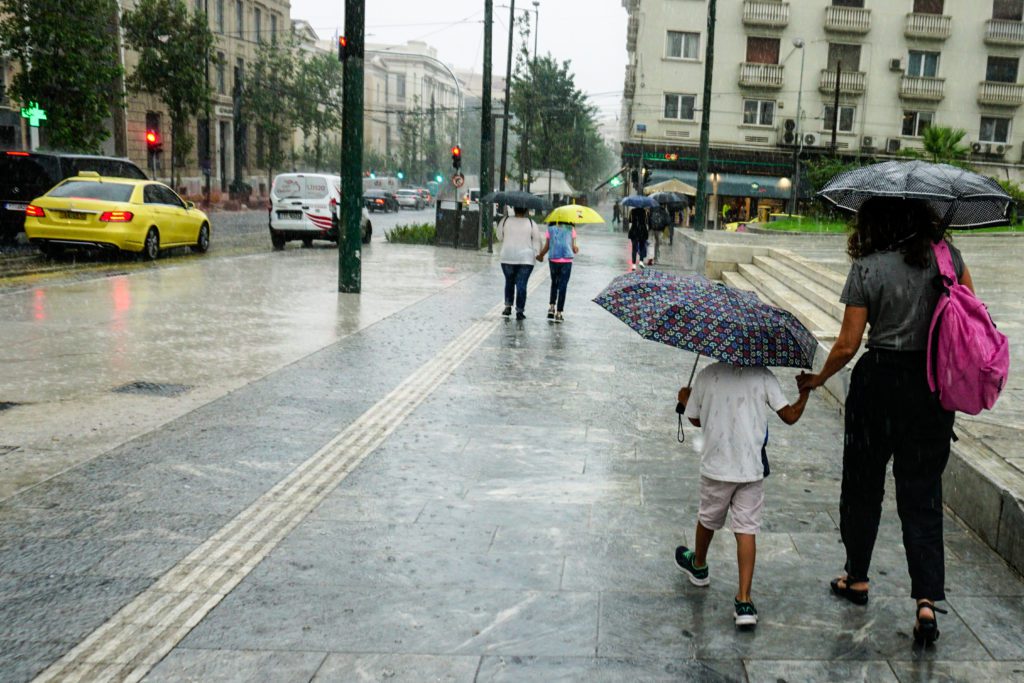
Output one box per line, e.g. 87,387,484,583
840,350,953,600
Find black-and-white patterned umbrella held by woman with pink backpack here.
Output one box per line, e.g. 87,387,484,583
818,161,1013,229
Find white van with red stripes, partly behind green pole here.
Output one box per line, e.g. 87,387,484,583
270,173,373,249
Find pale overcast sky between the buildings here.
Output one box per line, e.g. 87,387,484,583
292,0,627,116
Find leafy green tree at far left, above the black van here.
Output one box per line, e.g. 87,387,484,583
0,0,122,153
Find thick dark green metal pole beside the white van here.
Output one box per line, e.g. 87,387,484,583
338,0,366,294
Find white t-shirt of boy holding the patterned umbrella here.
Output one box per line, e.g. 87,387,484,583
685,362,788,483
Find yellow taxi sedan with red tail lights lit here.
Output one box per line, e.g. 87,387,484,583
25,171,210,260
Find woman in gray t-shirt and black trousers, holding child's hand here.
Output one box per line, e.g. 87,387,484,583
798,197,974,644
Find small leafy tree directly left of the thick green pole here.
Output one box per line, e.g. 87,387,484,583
295,54,344,171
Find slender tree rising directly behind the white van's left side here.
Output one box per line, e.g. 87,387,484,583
242,40,297,182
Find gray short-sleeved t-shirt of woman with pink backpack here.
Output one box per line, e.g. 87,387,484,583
840,245,964,351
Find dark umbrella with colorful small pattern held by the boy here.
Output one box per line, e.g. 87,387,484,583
594,271,817,368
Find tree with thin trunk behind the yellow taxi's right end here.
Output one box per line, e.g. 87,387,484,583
122,0,214,187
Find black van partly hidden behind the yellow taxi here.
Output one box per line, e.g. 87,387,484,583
0,152,146,243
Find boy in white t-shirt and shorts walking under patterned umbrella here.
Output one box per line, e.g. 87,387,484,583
676,362,810,627
